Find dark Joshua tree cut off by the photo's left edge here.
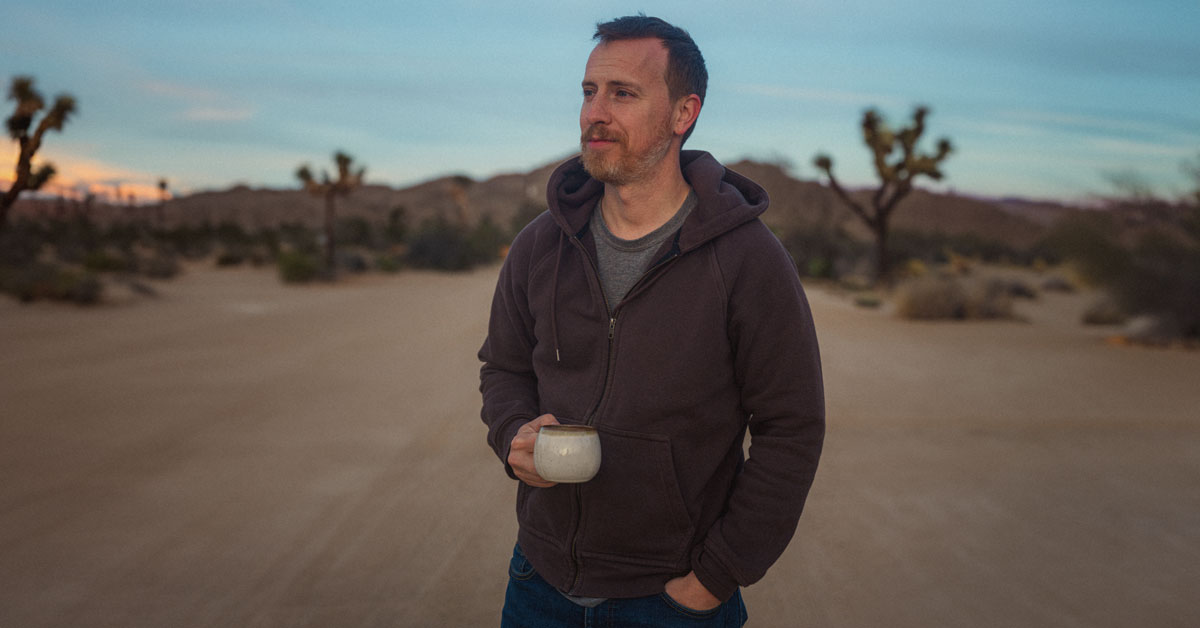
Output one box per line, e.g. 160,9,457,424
0,77,76,228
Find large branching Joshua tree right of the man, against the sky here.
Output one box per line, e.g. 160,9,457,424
812,107,952,281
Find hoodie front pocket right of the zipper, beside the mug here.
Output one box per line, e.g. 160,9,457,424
578,427,695,569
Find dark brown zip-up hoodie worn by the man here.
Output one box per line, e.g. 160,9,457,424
479,151,824,600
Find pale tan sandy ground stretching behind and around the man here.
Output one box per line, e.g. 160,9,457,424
0,268,1200,628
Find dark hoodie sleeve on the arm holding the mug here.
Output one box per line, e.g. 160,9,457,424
479,223,539,479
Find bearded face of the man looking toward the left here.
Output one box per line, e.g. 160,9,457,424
580,38,676,185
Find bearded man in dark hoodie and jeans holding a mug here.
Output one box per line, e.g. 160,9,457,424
479,16,824,627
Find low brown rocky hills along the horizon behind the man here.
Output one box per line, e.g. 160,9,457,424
13,156,1073,246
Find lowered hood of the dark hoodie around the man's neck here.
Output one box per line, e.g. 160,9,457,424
546,150,768,252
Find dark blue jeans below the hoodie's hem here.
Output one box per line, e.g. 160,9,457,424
500,545,746,628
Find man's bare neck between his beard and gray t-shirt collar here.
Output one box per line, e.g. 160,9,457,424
600,153,690,240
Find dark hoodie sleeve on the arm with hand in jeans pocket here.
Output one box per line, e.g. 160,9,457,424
692,221,824,599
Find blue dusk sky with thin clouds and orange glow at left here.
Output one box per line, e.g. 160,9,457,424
7,0,1200,201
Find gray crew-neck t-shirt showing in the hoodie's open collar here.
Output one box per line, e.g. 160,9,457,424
592,189,696,312
